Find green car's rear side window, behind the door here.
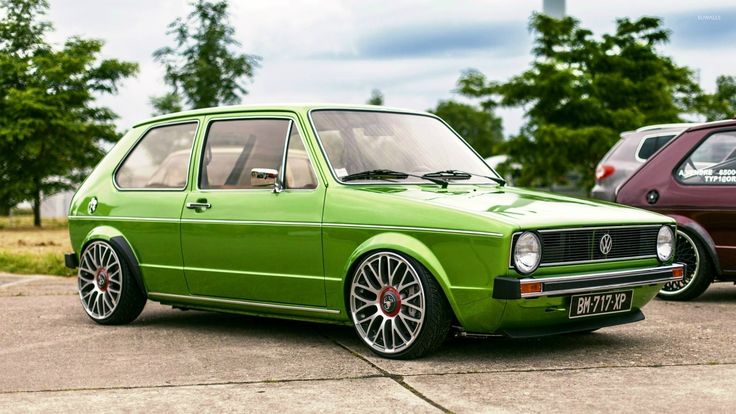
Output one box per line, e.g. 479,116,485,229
115,122,197,190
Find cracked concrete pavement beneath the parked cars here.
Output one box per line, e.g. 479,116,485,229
0,275,736,413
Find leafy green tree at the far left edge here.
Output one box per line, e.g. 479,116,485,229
0,0,138,226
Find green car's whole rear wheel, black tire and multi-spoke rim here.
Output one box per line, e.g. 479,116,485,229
77,240,146,325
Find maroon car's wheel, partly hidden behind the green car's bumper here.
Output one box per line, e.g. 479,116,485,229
657,230,714,301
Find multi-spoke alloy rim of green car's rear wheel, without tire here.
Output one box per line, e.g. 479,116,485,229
77,241,123,320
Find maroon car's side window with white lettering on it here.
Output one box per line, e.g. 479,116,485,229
675,131,736,185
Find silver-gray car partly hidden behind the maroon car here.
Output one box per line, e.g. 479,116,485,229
590,123,699,201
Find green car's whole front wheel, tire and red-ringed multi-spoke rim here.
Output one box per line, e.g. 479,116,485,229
348,251,452,359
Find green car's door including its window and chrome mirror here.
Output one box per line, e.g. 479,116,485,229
181,113,325,306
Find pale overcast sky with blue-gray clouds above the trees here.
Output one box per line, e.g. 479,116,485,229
47,0,736,134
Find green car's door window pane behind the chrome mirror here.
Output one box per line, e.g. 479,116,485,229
199,119,291,189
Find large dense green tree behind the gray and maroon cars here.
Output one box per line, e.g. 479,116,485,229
458,14,701,187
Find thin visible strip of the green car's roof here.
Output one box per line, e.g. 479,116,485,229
133,103,434,127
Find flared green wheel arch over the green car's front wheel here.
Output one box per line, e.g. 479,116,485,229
343,232,460,318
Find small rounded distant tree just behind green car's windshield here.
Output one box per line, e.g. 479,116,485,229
429,100,503,157
